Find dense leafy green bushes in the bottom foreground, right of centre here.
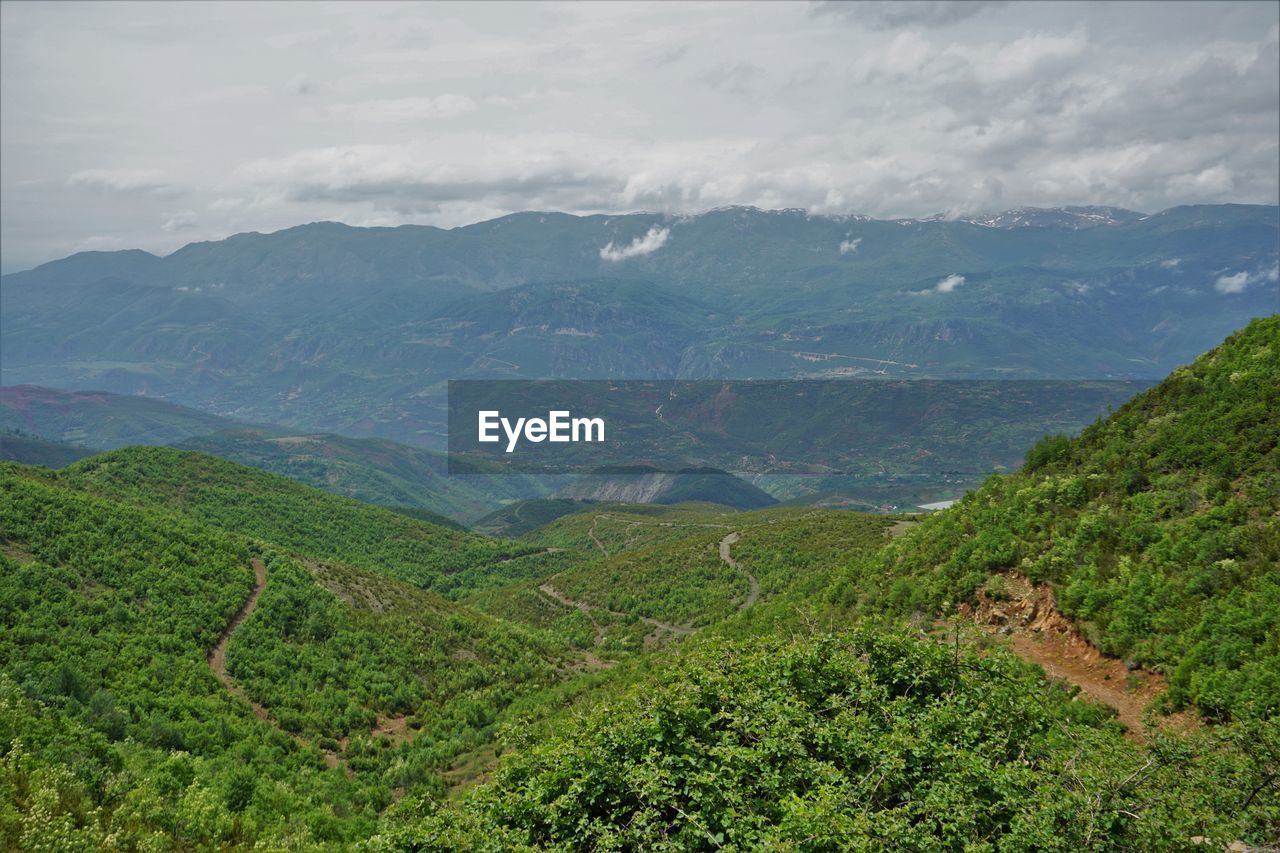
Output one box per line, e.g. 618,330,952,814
370,628,1280,852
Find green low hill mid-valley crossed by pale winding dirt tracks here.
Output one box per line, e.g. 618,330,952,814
465,503,911,661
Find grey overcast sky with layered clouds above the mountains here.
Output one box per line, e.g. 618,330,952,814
0,0,1280,272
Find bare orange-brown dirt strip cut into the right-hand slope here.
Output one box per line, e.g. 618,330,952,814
963,573,1190,742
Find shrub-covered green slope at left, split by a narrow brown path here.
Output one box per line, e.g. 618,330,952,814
0,465,581,849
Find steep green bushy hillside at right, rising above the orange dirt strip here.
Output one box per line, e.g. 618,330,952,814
835,316,1280,720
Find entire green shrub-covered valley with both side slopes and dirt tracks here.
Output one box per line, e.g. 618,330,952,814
0,318,1280,849
